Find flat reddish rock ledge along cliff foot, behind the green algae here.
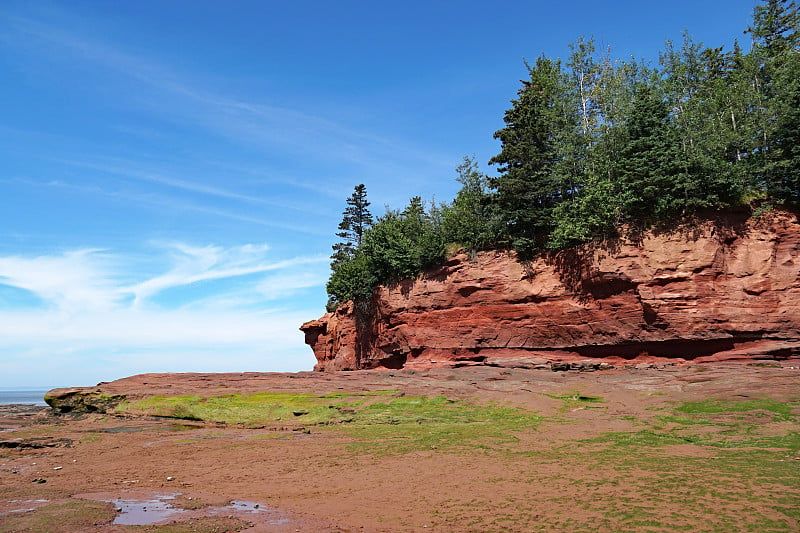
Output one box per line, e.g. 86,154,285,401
42,357,800,416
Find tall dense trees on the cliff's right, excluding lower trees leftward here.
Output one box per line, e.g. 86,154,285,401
490,0,800,252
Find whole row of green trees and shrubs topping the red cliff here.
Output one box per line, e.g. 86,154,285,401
327,0,800,310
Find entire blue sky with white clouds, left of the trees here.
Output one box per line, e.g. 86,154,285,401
0,0,755,387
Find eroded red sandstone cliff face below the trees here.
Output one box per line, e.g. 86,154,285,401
301,209,800,370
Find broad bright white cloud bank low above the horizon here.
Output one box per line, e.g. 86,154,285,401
0,243,327,385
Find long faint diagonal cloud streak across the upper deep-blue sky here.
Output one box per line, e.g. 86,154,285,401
0,7,453,184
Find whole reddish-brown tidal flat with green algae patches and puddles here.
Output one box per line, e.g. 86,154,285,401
0,361,800,533
